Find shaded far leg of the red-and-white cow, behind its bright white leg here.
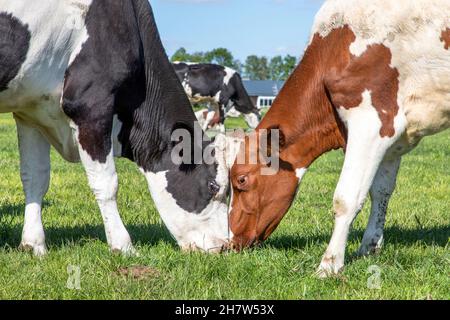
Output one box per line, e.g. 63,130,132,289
358,157,401,256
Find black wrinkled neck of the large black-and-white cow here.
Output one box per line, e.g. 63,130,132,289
119,1,196,171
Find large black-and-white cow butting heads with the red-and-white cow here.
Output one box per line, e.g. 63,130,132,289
0,0,232,255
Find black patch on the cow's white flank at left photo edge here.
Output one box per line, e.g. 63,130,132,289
0,12,31,91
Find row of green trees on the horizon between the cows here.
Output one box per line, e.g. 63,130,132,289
171,48,297,80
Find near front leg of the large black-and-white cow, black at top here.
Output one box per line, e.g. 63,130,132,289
76,122,135,254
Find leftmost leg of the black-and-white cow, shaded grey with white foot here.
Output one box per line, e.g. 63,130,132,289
15,116,50,256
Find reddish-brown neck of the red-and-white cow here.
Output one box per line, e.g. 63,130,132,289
259,28,354,169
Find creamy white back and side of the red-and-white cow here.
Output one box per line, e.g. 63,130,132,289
312,0,450,145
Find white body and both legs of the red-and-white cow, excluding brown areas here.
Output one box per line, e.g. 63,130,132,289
312,0,450,276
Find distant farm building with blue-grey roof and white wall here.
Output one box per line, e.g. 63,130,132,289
243,80,284,109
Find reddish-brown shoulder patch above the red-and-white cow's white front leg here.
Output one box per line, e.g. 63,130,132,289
325,44,399,137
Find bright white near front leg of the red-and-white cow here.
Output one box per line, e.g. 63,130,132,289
318,92,406,277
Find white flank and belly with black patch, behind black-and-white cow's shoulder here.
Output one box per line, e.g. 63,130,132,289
0,0,91,161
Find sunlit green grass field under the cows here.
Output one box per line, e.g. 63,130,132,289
0,115,450,299
